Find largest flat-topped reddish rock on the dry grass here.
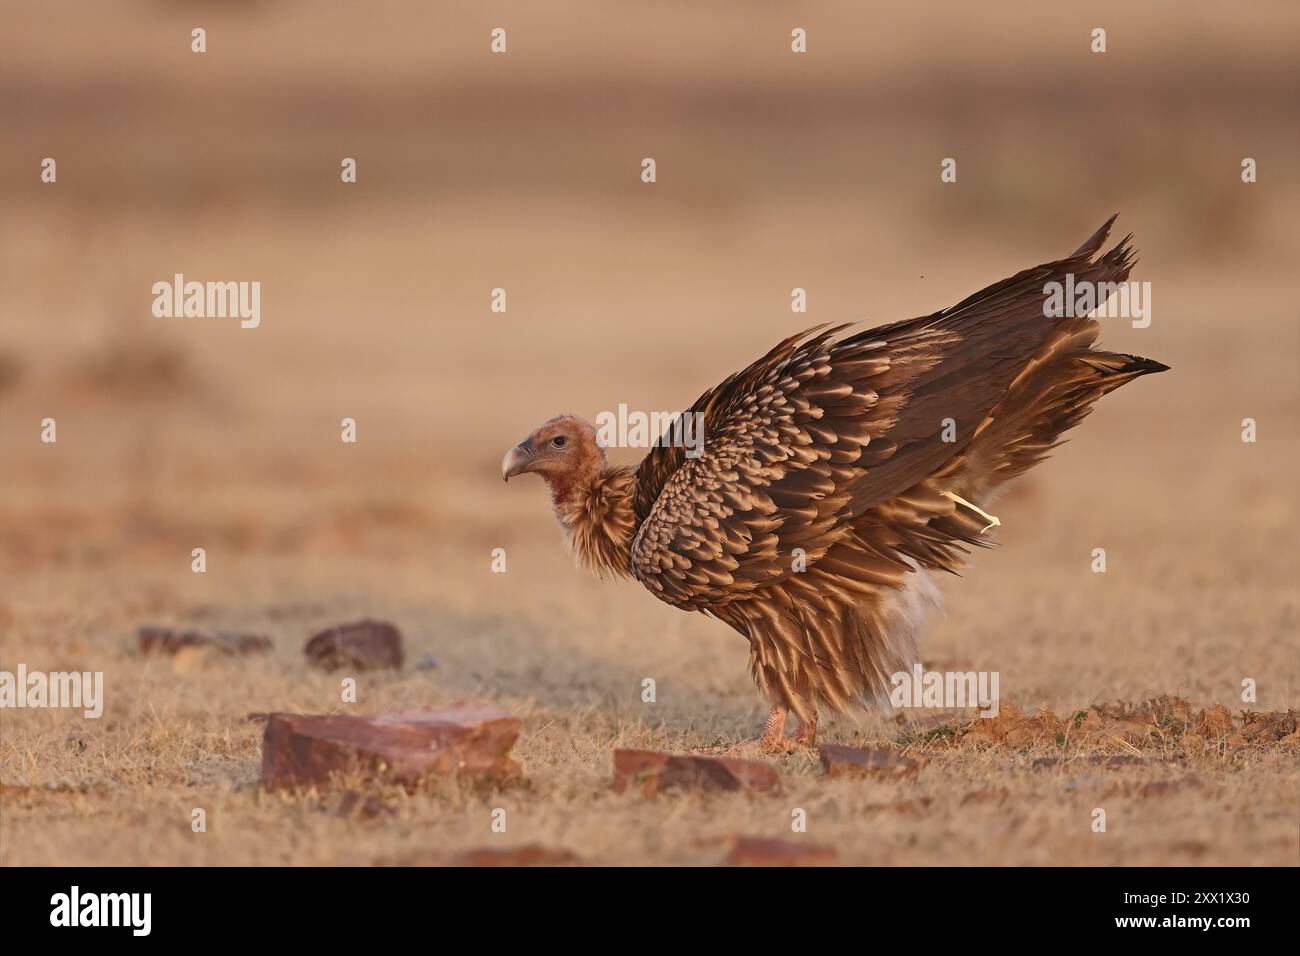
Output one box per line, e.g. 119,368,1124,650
261,705,520,788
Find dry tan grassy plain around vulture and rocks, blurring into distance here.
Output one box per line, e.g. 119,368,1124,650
0,0,1300,865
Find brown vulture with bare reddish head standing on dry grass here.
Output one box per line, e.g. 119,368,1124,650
502,216,1167,753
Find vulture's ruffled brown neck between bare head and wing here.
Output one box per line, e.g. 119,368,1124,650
549,468,636,578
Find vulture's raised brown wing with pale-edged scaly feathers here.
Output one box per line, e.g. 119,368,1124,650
631,217,1132,609
